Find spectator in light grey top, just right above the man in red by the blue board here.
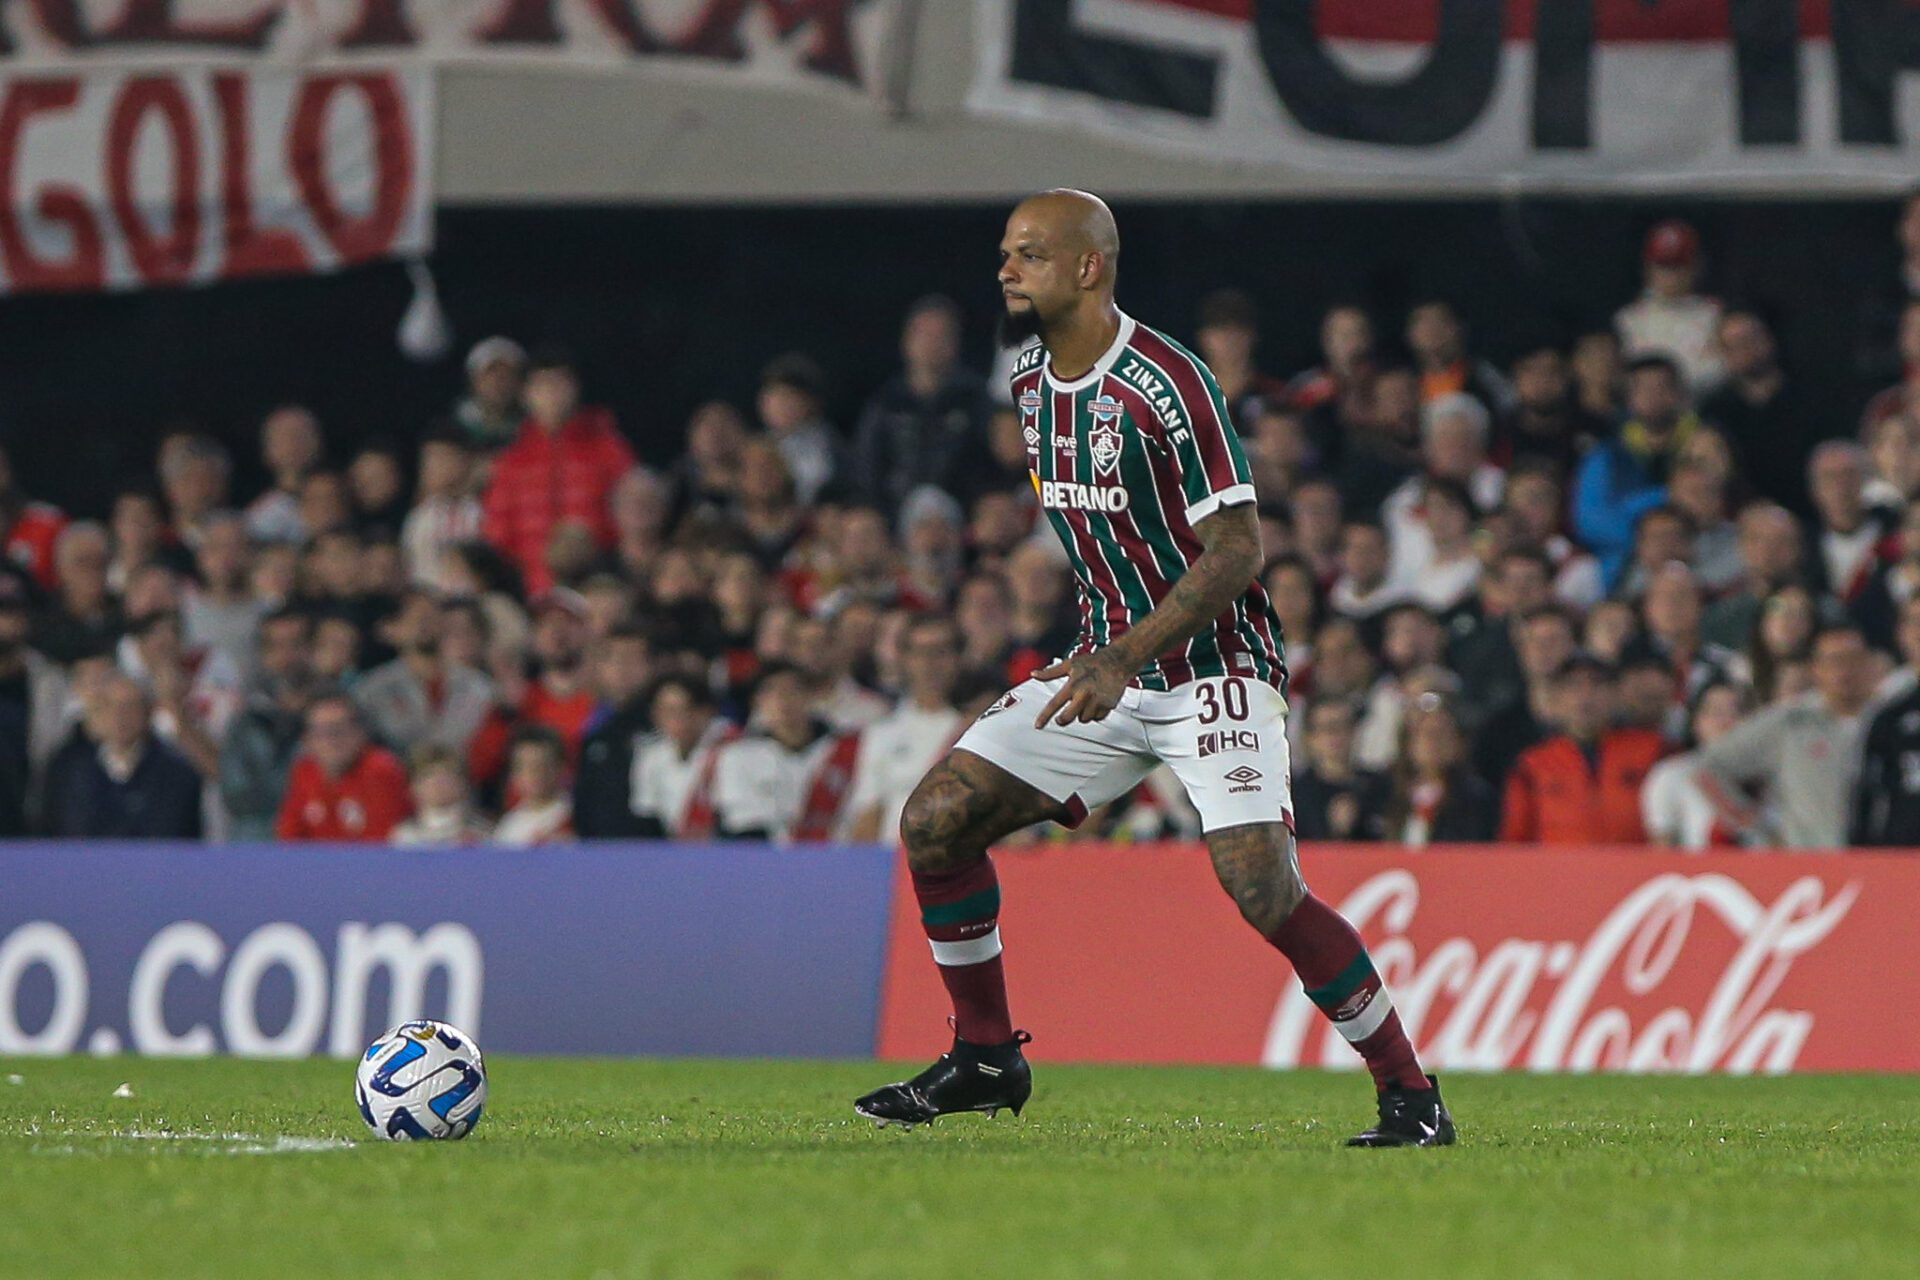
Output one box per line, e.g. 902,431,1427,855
353,589,505,779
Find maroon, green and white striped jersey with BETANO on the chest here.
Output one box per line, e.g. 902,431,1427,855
1012,315,1286,691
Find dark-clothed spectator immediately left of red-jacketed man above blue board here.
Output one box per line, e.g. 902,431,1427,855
219,608,315,842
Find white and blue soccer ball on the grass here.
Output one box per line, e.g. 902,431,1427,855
353,1019,486,1142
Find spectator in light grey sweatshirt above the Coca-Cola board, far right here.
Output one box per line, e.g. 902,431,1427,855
1695,624,1874,848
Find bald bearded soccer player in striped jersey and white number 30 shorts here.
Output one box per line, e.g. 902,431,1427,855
854,190,1453,1148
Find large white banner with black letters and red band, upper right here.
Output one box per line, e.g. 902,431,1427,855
968,0,1920,194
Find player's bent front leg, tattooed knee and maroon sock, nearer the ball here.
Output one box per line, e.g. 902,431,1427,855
900,750,1066,1046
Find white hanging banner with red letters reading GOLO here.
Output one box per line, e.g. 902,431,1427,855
0,67,434,294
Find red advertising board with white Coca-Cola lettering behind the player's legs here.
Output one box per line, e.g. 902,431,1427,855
877,844,1920,1073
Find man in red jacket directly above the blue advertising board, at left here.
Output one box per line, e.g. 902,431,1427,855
275,693,413,842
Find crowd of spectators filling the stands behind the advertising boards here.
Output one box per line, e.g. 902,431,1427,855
11,210,1920,848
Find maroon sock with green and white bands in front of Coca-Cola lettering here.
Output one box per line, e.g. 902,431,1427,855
1267,894,1428,1088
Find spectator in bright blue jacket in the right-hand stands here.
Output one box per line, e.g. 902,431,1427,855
1572,355,1699,587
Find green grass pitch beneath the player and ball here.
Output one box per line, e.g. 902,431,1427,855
0,1057,1920,1280
